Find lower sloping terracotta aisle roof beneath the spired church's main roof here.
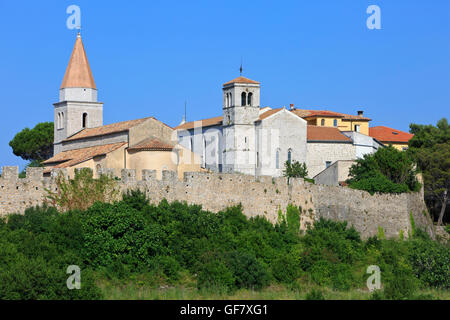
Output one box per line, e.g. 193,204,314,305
44,142,127,168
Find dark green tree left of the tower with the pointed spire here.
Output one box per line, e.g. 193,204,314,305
9,122,53,162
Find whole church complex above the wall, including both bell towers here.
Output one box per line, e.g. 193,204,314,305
44,34,383,179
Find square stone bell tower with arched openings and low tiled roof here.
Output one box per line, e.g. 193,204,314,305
223,76,260,174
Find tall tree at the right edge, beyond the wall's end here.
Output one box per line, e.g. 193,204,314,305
408,118,450,225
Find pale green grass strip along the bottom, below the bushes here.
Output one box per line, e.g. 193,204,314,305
98,280,450,300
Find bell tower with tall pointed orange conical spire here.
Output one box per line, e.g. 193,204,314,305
54,33,103,155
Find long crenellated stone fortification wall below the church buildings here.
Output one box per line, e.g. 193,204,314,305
0,167,433,238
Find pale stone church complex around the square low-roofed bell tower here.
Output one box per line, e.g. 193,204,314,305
175,76,382,177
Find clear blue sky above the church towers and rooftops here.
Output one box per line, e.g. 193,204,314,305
0,0,450,167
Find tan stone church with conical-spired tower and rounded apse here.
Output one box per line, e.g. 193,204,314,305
44,34,201,179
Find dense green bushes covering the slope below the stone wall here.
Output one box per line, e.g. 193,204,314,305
0,191,450,299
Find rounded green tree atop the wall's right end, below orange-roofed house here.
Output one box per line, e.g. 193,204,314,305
347,146,420,194
